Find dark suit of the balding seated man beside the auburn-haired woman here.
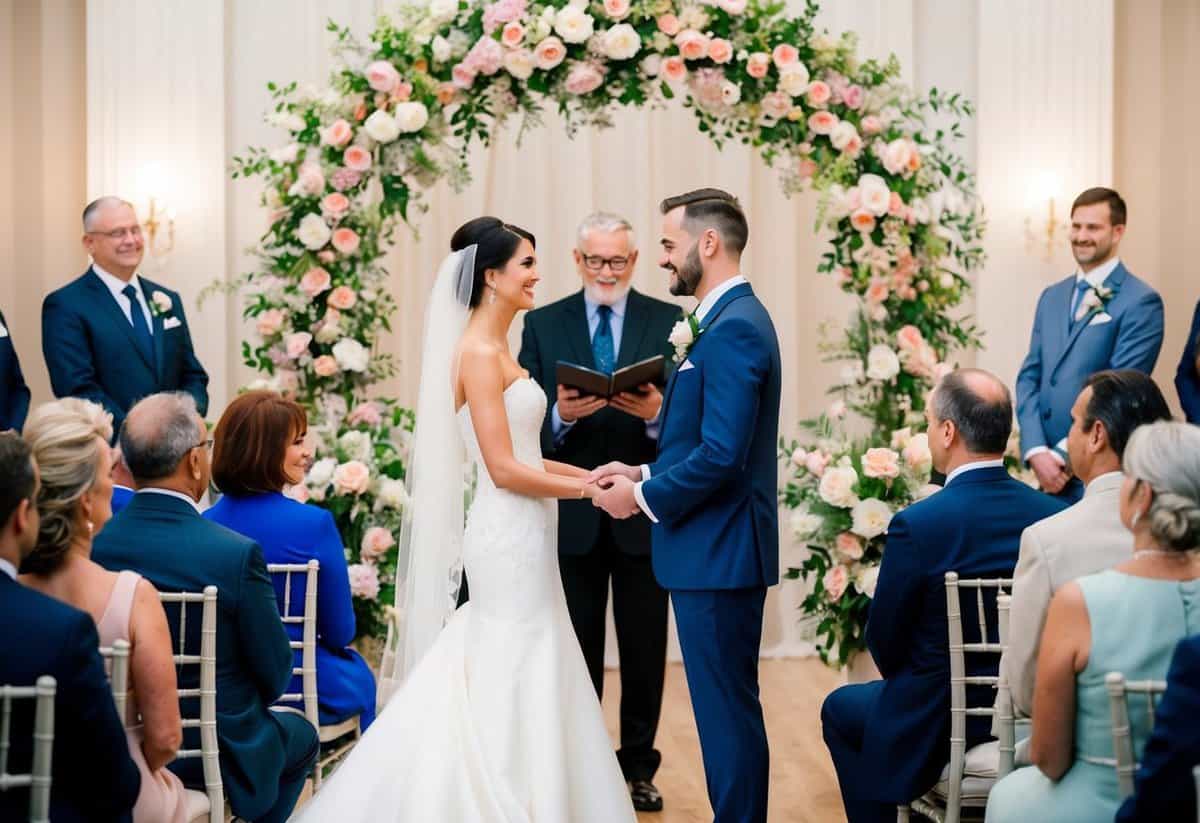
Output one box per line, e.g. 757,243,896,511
92,492,317,821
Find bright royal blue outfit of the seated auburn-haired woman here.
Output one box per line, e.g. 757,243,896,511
204,492,376,729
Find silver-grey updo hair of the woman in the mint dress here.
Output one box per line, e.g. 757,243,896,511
1123,421,1200,552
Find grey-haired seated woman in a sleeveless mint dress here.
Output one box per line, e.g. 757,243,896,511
988,422,1200,823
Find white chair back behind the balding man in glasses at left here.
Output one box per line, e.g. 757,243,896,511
158,585,224,823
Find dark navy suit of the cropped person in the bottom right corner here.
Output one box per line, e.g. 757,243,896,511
1116,635,1200,823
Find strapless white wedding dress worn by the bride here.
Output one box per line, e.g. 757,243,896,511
295,378,635,823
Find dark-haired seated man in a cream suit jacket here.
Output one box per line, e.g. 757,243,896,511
1000,368,1171,717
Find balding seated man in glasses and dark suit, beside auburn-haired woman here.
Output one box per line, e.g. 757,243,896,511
92,392,317,822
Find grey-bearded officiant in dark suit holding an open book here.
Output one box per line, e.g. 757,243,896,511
517,212,682,811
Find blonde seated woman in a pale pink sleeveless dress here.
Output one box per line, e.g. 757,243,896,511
20,397,187,823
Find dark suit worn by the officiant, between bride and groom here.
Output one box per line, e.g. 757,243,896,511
518,283,680,781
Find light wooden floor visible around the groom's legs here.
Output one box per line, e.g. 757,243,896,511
604,659,846,823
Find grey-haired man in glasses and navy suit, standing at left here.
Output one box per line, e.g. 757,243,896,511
42,197,209,435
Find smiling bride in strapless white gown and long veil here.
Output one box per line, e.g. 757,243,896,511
296,217,635,823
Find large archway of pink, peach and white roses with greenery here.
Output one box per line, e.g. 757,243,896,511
233,0,983,662
